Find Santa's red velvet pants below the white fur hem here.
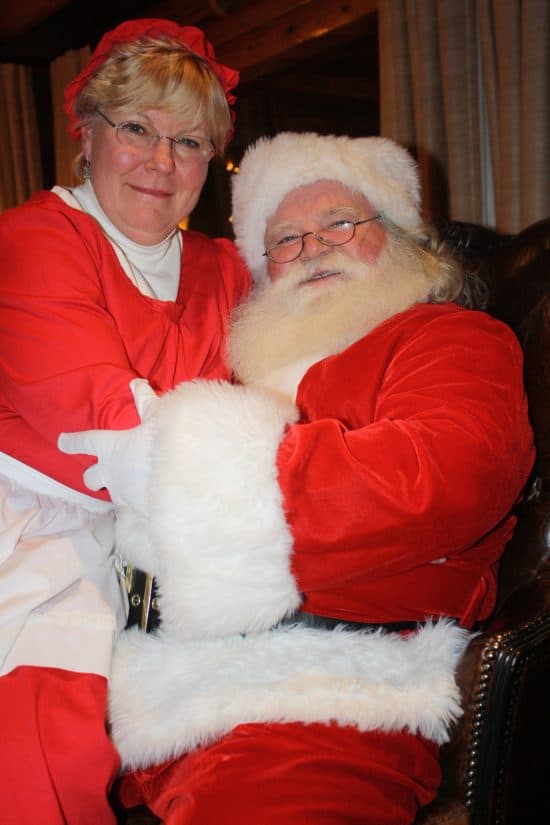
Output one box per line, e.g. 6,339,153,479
119,724,440,825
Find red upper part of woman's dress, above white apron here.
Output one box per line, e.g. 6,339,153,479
0,192,249,498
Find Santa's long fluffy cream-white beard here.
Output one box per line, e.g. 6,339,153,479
228,244,436,383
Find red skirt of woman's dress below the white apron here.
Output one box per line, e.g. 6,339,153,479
0,667,120,825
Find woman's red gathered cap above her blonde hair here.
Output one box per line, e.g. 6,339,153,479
64,18,239,140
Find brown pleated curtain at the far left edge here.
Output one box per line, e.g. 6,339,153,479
0,63,43,211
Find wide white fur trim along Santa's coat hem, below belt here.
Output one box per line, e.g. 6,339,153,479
110,621,470,768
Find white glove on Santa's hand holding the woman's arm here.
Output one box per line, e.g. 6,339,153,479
57,378,159,517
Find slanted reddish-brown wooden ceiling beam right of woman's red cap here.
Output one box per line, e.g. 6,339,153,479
210,0,378,81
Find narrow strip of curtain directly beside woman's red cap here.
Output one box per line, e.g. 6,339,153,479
50,46,90,186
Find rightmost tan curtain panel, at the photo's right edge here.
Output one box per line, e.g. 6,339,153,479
478,0,550,231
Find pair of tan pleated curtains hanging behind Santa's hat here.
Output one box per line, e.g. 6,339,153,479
379,0,550,232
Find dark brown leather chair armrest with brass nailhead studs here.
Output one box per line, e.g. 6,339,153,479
417,562,550,825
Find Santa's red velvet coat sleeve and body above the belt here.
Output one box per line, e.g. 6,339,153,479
278,304,534,626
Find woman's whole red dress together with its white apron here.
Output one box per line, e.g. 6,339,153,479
0,192,249,825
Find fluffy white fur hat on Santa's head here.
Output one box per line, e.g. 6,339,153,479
232,132,422,281
